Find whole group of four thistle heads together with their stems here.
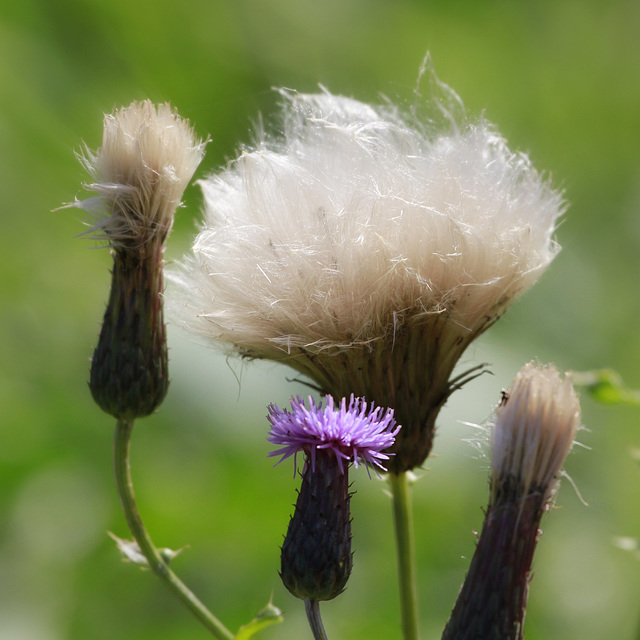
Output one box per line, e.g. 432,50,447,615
69,63,580,640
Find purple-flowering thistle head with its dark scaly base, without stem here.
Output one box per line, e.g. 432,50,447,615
268,396,400,601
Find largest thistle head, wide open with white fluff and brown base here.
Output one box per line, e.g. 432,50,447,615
172,65,563,471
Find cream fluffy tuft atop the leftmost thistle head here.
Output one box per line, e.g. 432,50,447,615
70,100,206,249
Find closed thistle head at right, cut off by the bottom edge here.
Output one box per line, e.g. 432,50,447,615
442,363,580,640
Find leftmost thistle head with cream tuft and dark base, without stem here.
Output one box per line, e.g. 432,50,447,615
69,101,204,419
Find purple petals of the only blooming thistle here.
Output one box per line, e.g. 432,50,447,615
267,394,400,473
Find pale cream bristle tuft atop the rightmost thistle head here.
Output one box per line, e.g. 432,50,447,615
491,362,580,498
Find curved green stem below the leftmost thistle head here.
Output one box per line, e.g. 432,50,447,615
113,420,234,640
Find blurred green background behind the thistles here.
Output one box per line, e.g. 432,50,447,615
0,0,640,640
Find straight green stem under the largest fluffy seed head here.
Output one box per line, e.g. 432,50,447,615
389,471,418,640
